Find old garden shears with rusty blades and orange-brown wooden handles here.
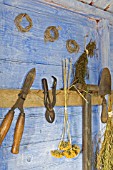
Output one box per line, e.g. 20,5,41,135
0,68,36,154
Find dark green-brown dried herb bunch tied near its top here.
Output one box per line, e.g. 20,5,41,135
70,41,96,90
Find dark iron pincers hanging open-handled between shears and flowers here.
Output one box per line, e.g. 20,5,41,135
42,76,57,123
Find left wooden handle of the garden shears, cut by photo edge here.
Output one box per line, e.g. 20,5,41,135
0,110,14,145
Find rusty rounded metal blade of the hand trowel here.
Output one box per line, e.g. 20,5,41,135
99,68,111,96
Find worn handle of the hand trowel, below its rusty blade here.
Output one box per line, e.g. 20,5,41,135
101,97,108,123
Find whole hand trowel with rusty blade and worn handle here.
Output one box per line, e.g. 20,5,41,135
99,68,111,123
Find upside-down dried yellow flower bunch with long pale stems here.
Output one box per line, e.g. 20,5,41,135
51,60,80,158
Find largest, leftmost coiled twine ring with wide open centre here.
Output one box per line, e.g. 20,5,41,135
14,13,33,32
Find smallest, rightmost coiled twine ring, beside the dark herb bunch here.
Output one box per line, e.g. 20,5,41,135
66,39,80,53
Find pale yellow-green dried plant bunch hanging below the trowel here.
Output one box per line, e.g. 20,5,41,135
97,116,113,170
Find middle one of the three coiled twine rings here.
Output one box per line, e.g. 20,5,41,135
44,26,59,42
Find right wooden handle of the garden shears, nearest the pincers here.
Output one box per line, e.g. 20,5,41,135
11,113,25,154
